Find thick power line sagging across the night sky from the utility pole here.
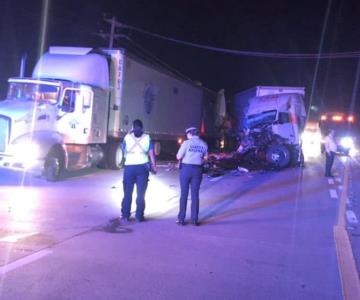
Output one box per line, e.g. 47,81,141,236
105,18,360,59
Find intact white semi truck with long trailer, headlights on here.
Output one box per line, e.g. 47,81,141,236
0,47,216,180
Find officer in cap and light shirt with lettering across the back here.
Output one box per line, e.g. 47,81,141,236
176,127,208,226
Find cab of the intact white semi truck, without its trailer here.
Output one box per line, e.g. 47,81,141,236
0,49,112,180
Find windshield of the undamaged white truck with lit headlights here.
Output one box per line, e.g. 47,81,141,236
6,82,60,104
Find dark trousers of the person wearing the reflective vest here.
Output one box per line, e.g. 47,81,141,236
121,164,149,219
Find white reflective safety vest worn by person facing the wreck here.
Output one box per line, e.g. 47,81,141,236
124,133,150,165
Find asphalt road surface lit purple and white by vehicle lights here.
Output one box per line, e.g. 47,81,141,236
0,160,360,299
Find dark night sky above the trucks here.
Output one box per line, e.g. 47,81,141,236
0,0,360,117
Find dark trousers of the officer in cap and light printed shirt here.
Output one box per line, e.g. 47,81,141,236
178,164,202,222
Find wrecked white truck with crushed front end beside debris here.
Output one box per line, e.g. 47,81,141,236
233,86,306,168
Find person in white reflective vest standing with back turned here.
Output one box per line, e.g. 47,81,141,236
121,120,156,223
